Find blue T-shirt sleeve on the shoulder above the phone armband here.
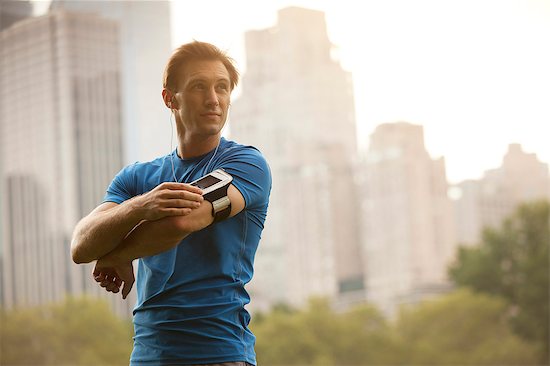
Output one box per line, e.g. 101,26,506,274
219,147,271,209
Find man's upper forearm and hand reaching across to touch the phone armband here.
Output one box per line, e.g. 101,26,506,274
71,182,203,263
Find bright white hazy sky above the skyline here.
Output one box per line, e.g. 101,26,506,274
35,0,550,182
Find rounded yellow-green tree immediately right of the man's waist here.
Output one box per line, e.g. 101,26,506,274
252,299,393,365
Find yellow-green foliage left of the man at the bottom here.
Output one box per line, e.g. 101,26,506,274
0,298,133,365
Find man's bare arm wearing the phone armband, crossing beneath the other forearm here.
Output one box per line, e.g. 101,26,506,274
93,185,245,298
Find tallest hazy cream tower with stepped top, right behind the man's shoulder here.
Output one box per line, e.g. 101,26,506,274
230,7,363,308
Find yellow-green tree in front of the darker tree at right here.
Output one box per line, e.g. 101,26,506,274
395,289,538,366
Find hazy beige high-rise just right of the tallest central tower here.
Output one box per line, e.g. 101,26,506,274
360,122,454,314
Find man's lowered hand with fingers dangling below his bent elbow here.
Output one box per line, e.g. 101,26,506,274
93,255,135,299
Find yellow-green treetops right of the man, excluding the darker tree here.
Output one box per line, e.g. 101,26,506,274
252,290,537,366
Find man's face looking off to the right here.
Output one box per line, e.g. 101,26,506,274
174,61,231,139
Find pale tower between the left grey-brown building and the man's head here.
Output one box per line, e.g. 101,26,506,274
50,0,172,164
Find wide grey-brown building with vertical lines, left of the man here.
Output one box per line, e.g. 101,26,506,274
0,7,128,312
